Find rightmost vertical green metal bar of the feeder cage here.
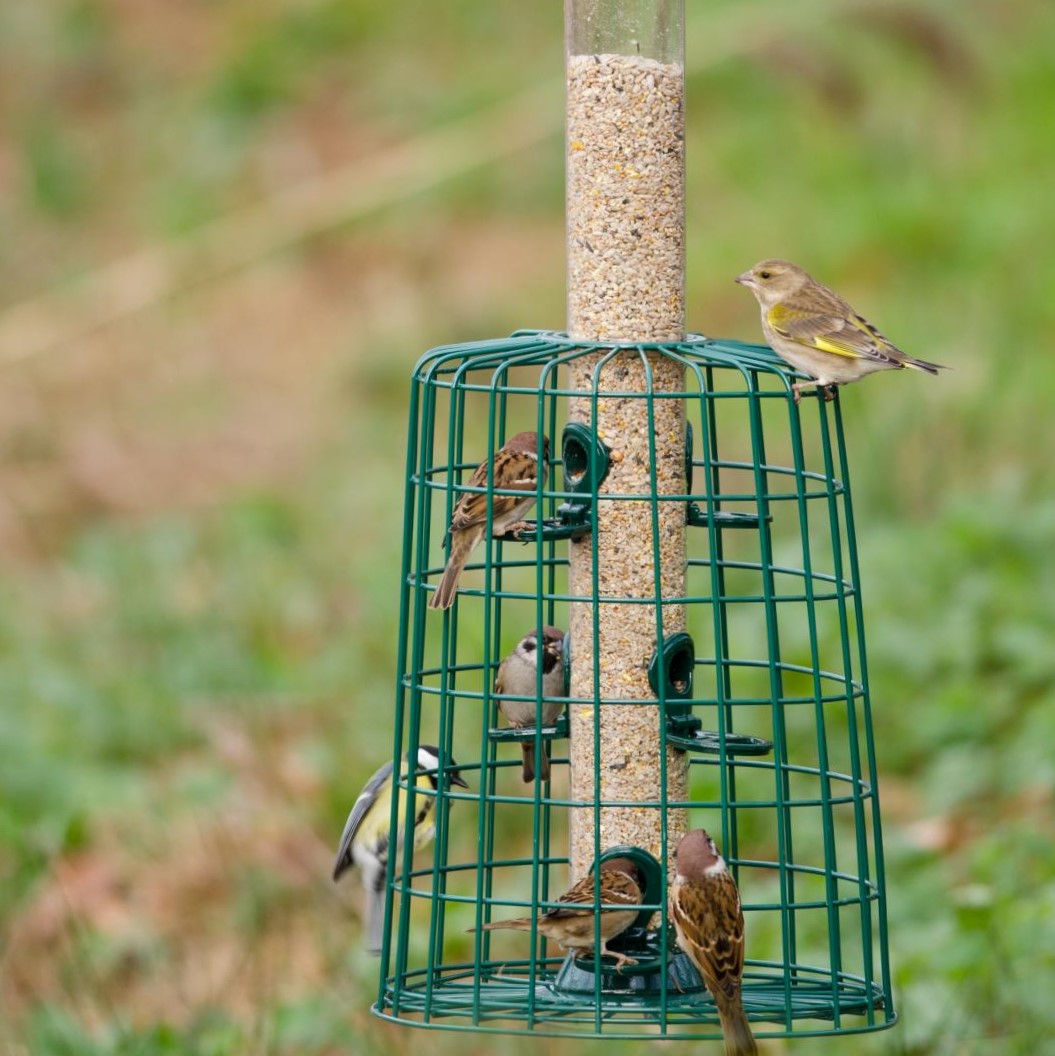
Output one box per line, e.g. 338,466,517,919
834,400,894,1023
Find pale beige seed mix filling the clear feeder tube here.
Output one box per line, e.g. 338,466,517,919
567,55,687,879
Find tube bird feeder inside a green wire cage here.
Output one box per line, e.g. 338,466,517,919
374,0,896,1038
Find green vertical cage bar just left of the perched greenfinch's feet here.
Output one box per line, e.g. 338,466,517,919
749,375,797,1032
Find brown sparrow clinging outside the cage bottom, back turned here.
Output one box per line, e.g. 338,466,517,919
670,829,758,1056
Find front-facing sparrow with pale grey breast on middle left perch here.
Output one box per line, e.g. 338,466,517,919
494,626,564,784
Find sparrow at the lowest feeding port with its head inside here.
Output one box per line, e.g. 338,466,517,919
477,857,644,970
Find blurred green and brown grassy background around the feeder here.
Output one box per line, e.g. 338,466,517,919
0,0,1055,1056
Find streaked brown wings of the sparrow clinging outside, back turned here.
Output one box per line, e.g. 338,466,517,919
671,876,743,998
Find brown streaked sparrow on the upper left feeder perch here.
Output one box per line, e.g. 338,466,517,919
429,433,549,608
